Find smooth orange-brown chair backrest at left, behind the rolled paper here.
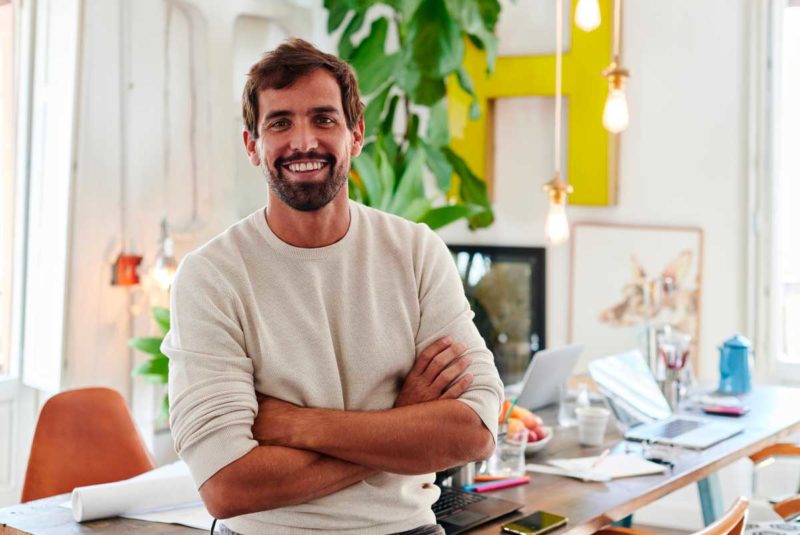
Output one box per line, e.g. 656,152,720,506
22,388,155,502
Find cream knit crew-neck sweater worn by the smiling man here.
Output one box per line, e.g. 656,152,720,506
162,202,502,534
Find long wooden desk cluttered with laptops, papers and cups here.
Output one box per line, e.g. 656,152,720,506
0,386,800,535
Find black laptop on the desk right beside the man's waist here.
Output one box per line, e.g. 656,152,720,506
432,467,523,535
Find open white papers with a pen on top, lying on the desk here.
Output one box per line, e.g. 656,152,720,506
526,454,667,481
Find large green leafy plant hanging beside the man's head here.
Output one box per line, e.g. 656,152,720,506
324,0,500,229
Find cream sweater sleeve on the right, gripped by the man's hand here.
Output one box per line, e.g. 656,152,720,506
415,227,503,442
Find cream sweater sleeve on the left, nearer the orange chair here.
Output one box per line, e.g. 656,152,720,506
161,254,258,487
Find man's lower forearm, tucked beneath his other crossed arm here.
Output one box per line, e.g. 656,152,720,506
200,446,375,518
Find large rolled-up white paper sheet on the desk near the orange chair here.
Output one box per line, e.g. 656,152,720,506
60,461,213,529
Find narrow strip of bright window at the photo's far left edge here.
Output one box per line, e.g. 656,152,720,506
0,0,15,378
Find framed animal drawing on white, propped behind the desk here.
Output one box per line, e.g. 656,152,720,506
569,223,703,370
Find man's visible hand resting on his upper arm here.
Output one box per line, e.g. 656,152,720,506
394,337,473,407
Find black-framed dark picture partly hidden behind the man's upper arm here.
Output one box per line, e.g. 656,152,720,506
448,245,545,385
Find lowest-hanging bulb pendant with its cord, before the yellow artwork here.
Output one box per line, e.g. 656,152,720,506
543,0,572,245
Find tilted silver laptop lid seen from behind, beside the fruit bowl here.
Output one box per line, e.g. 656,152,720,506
506,344,583,410
